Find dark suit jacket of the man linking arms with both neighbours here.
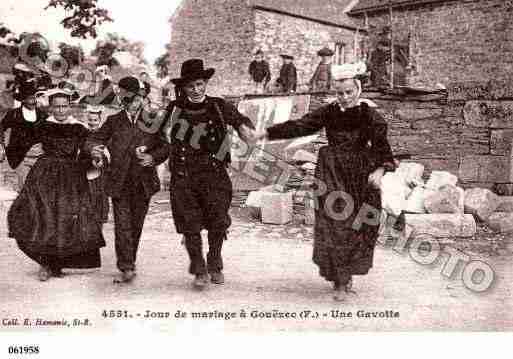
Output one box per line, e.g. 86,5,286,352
86,110,169,197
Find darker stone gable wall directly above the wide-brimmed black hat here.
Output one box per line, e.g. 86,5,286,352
169,0,255,95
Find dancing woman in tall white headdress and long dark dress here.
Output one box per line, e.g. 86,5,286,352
254,64,394,300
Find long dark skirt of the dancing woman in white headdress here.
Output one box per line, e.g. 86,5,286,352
313,146,381,283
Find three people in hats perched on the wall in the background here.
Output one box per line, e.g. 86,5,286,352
248,47,335,94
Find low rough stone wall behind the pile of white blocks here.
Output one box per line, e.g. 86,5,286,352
232,83,513,189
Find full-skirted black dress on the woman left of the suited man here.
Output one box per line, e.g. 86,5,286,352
8,122,105,269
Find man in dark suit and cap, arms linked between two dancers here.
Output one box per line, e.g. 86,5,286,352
86,76,169,283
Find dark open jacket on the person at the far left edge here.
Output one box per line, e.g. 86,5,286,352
0,106,48,169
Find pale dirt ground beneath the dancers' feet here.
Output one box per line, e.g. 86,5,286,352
0,193,513,334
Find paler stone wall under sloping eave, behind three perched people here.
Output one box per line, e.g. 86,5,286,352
255,10,360,90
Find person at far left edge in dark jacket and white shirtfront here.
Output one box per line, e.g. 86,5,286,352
0,79,48,190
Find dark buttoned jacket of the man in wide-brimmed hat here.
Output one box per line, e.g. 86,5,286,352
163,96,254,173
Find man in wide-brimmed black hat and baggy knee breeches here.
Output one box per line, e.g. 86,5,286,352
164,59,254,289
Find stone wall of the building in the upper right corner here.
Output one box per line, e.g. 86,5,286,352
350,0,513,86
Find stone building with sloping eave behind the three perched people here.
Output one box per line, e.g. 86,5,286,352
169,0,364,95
